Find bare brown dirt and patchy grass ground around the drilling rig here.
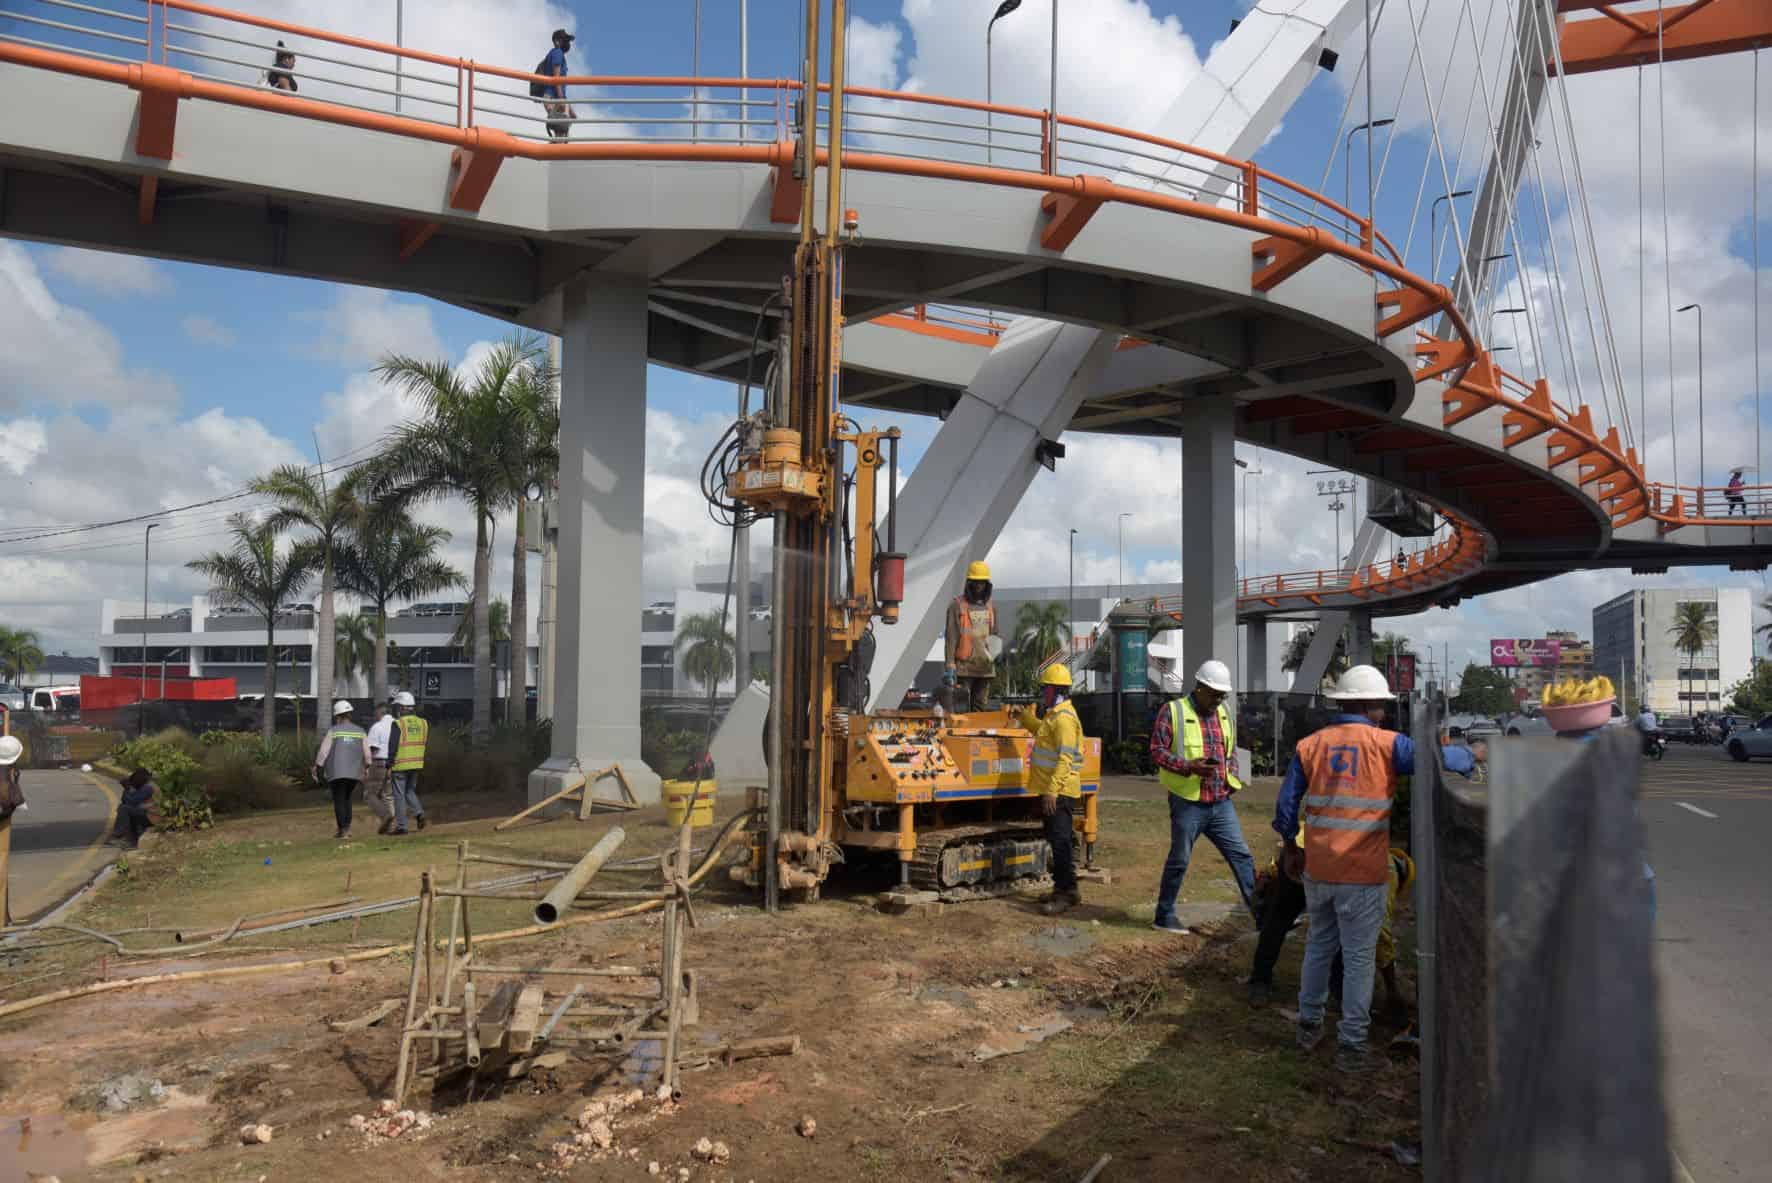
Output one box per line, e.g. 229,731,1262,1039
0,777,1416,1183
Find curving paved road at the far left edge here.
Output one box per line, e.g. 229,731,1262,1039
9,772,117,921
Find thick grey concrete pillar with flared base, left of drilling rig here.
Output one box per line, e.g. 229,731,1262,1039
528,274,659,802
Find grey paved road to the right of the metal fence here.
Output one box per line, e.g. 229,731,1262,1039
1643,744,1772,1183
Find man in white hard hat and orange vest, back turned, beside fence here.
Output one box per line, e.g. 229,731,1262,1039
1274,666,1416,1073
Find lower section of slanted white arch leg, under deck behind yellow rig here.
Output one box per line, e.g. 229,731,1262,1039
870,321,1116,708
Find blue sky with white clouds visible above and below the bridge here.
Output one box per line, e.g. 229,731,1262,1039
0,0,1772,680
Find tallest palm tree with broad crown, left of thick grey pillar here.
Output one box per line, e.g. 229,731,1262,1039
374,333,549,740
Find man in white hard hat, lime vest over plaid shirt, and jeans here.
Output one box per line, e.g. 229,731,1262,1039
1150,661,1255,933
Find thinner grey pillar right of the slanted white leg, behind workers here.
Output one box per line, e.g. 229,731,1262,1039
1180,395,1244,691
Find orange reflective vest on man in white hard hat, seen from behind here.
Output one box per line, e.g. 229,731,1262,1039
1297,723,1396,884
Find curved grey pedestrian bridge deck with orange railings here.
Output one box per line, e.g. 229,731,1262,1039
0,0,1772,637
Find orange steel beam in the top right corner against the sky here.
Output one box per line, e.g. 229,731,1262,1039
1547,0,1772,74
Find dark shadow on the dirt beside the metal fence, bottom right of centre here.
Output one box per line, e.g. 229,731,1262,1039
999,921,1419,1183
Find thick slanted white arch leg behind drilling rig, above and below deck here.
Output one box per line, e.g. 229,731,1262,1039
870,0,1357,708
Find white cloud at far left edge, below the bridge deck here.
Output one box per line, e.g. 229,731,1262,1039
0,241,177,414
